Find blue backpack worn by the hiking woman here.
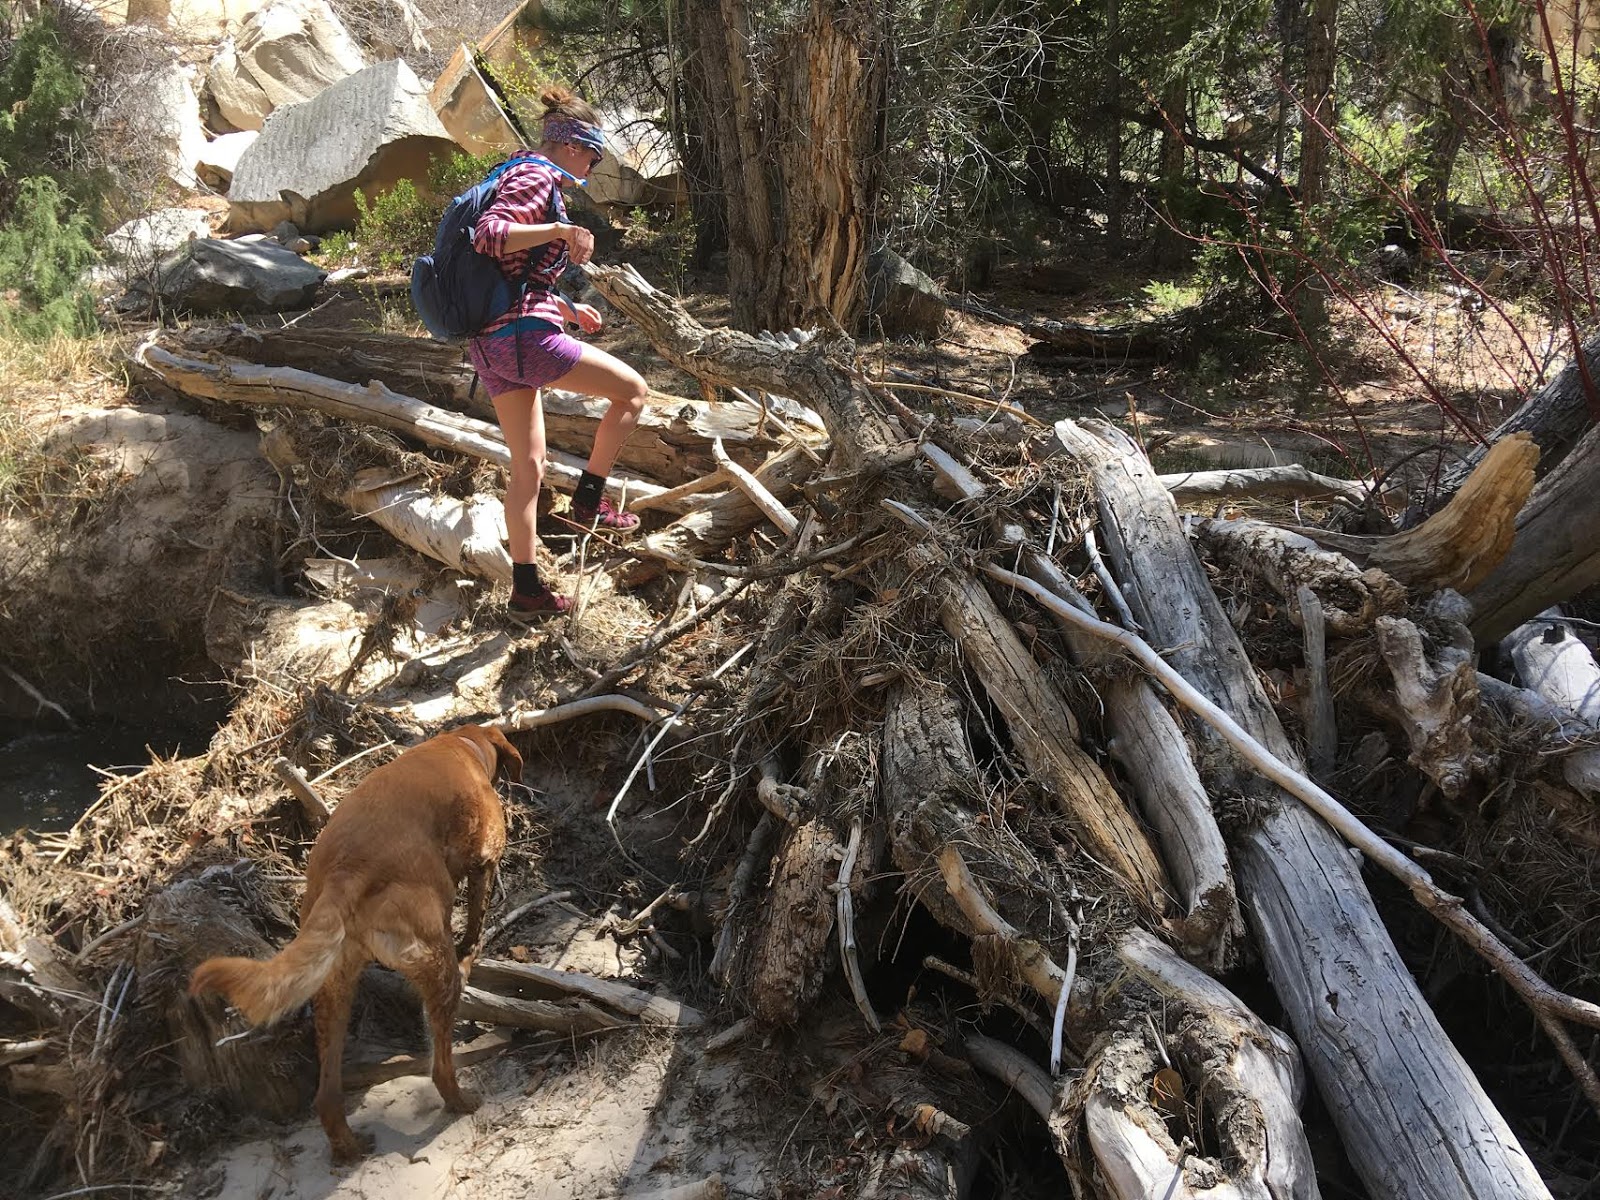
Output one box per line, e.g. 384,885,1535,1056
411,154,555,341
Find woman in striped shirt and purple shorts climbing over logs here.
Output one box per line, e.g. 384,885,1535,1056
467,88,648,624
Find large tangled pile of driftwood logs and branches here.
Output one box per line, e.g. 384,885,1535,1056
9,267,1600,1200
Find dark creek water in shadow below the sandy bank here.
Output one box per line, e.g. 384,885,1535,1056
0,720,214,837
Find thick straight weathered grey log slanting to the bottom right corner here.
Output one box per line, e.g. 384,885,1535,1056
1056,421,1549,1200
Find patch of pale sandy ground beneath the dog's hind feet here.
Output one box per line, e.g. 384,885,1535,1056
184,1034,773,1200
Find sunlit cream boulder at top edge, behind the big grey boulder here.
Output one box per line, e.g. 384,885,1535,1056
206,0,366,130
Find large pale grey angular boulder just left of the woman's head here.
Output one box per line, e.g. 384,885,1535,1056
227,59,456,234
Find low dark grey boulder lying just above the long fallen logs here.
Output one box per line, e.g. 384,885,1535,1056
118,237,326,315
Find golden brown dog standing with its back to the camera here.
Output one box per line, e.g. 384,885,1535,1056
189,725,522,1163
